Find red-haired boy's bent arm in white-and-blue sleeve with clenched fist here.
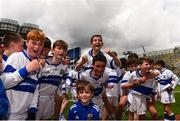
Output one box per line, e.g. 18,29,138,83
1,54,41,89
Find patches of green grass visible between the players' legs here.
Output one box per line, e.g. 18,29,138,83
64,85,180,120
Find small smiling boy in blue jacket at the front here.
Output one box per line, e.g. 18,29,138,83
68,80,99,120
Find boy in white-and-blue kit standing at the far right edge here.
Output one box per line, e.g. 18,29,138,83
156,60,179,120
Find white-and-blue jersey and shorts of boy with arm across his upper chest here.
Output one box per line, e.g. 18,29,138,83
128,69,157,115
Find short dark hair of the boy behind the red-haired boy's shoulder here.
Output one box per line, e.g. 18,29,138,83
3,32,22,47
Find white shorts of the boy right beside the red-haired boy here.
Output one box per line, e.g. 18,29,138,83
36,96,55,120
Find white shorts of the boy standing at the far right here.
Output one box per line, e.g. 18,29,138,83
160,90,175,104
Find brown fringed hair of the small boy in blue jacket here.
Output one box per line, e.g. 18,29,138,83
76,80,94,94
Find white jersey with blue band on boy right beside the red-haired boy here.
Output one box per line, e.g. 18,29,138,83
38,58,67,97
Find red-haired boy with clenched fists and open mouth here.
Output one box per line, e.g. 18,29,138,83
1,30,45,120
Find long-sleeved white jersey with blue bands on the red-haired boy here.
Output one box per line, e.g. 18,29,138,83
1,51,39,120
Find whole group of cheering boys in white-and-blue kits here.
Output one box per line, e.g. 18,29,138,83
0,30,179,120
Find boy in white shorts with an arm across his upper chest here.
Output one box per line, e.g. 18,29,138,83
122,58,159,120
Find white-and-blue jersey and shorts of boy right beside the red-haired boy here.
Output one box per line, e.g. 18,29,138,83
36,57,68,119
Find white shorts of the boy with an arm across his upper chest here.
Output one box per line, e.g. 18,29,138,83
128,93,147,115
